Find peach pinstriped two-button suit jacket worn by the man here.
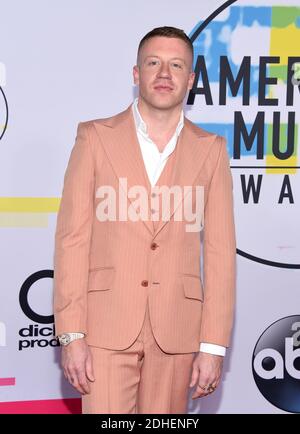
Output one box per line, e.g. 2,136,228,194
54,105,236,353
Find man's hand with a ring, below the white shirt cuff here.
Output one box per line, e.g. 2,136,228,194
190,351,224,399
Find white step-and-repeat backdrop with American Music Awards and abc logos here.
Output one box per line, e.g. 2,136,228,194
0,0,300,414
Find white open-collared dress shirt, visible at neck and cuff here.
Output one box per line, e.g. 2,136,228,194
132,98,226,356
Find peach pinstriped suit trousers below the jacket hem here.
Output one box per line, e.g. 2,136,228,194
82,294,195,414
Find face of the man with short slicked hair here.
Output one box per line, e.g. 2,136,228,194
133,36,195,110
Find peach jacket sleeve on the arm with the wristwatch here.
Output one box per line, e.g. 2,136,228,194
53,122,95,335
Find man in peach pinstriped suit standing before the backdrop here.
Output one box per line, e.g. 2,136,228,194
54,27,236,414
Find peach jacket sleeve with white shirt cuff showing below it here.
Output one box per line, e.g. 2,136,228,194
200,136,236,347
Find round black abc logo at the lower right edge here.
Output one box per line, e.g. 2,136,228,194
252,315,300,413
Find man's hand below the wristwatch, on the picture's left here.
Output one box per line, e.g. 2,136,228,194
61,338,95,395
